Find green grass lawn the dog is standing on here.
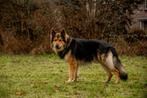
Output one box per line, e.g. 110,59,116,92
0,55,147,98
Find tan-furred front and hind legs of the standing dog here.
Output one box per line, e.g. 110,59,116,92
64,51,120,83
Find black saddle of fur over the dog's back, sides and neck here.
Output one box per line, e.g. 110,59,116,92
58,38,114,62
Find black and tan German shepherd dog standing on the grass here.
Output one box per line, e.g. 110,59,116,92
50,30,128,83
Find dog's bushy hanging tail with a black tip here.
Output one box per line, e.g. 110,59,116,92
111,48,128,81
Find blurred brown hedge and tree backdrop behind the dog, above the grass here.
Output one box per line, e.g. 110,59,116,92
0,0,147,56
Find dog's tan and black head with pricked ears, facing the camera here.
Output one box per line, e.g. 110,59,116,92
50,30,69,53
